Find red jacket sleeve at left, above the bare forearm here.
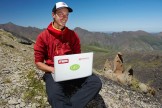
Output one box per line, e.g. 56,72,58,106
34,33,47,63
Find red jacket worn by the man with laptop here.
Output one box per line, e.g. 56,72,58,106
34,23,81,66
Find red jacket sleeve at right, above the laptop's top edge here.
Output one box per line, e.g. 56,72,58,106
73,32,81,54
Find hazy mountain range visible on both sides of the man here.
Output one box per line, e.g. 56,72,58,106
0,22,162,52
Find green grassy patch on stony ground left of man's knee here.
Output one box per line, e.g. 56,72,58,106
23,70,47,108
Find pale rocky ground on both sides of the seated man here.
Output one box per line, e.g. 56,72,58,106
0,30,162,108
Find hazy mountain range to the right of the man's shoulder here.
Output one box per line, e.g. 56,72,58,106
74,27,162,51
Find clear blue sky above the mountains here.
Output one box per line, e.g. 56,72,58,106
0,0,162,32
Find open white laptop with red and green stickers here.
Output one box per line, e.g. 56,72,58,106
52,52,93,82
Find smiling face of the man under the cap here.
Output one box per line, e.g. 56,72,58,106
54,8,69,27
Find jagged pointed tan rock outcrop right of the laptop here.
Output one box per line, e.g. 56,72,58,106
103,52,133,85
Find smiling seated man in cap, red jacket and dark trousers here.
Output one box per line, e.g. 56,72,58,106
34,2,102,108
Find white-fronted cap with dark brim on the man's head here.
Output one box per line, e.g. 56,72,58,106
52,2,73,12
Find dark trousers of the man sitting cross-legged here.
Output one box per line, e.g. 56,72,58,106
43,73,102,108
